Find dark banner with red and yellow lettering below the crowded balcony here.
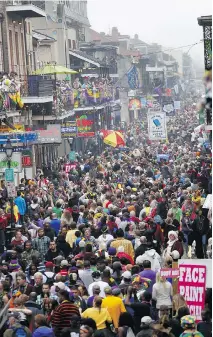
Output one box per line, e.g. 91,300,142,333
76,111,95,137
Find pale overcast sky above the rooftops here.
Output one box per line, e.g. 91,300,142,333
88,0,212,61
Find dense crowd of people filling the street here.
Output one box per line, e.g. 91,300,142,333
0,103,212,337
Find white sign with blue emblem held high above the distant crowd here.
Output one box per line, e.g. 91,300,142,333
147,109,167,140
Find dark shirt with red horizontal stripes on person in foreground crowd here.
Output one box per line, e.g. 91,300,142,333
51,301,80,331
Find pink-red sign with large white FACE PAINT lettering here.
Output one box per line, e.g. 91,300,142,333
178,264,206,321
